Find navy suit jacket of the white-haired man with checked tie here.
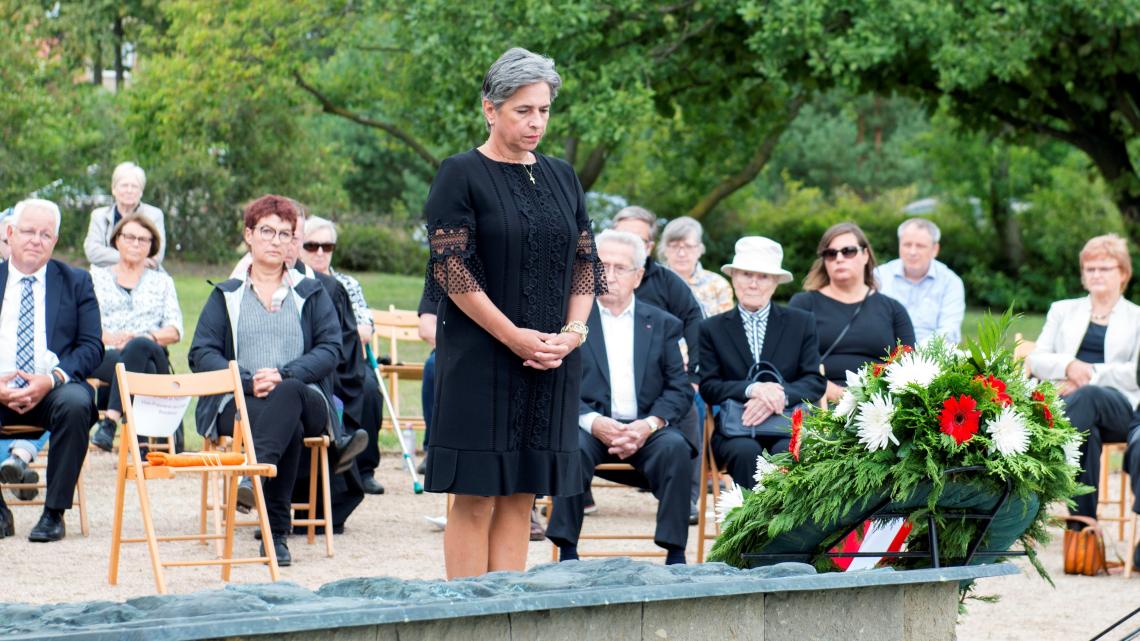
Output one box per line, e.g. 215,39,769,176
0,259,103,391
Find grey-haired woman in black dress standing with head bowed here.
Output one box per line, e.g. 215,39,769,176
424,49,605,578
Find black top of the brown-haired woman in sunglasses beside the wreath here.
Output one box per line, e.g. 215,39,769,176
788,291,914,386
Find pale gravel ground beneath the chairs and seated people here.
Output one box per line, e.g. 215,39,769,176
0,452,1140,641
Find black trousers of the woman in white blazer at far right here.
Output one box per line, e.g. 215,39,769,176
1065,386,1132,519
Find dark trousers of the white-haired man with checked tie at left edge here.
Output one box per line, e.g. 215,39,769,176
0,383,97,510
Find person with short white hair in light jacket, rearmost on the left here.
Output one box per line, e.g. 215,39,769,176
83,162,166,269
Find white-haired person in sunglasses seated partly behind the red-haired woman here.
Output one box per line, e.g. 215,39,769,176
295,214,384,495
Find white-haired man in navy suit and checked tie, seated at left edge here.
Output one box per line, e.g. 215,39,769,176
0,200,103,542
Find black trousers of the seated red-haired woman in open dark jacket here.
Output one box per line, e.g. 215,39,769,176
217,379,328,535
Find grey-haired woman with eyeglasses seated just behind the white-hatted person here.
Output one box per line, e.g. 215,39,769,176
658,216,733,318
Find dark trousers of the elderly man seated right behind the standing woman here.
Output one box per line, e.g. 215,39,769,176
546,428,697,550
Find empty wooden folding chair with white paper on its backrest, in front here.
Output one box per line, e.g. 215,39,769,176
107,360,278,593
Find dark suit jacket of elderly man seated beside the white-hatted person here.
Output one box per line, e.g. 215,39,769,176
578,300,697,447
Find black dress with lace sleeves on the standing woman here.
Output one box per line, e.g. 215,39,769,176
424,149,605,496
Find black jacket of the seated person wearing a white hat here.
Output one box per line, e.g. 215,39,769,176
701,303,827,407
